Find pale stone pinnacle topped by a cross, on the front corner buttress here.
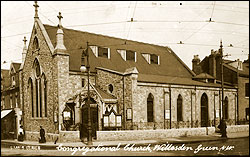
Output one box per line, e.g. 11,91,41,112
55,12,66,52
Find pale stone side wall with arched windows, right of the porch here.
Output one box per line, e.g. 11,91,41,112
133,82,236,130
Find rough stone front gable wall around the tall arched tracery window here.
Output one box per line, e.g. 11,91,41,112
22,22,56,133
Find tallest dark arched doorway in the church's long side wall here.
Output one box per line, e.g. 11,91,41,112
201,93,208,127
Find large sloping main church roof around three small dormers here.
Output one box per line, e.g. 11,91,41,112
44,25,194,78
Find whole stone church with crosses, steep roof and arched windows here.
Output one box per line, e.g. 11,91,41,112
20,3,237,141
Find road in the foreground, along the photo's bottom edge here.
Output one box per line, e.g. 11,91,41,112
1,137,249,156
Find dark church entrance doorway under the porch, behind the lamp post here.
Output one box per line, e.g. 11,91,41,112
80,98,98,138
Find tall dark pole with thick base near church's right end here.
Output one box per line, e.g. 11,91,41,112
220,41,227,137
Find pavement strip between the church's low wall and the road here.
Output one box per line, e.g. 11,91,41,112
1,132,249,150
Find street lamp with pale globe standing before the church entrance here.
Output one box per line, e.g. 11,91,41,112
80,42,92,145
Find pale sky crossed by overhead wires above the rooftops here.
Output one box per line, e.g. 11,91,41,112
1,1,249,69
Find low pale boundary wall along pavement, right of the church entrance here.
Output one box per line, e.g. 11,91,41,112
97,127,215,141
